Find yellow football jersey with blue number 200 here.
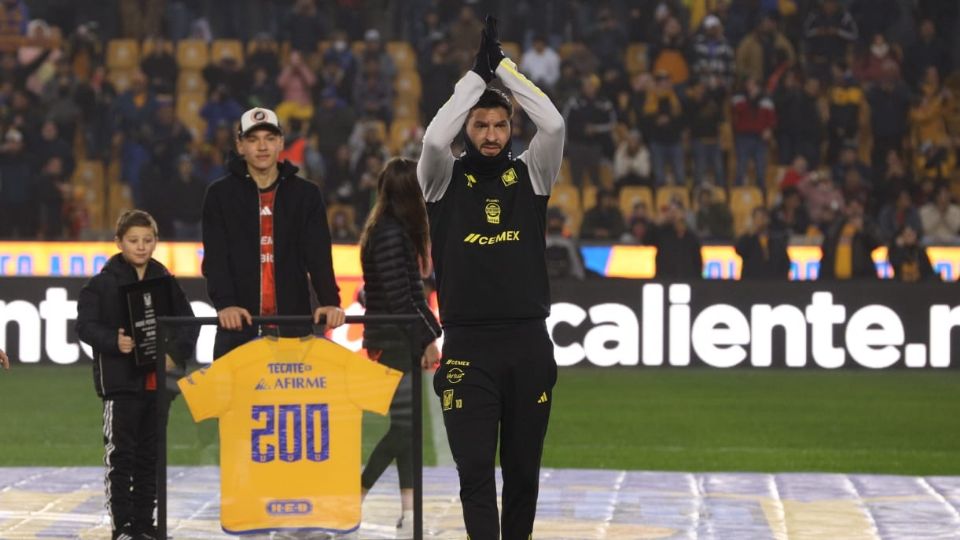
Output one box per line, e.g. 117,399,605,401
178,338,402,534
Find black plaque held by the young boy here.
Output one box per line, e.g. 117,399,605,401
120,276,172,367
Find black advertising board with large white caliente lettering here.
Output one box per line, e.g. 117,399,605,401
0,277,960,369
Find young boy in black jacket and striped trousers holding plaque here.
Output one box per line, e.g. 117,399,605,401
76,210,197,539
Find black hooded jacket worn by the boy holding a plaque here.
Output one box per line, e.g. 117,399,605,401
76,253,200,399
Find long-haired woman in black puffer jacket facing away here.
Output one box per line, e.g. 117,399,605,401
360,158,441,538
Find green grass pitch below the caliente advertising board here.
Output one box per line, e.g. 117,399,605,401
0,365,960,475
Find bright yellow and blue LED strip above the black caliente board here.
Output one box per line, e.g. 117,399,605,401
0,242,960,282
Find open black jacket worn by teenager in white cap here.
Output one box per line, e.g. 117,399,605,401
202,152,340,330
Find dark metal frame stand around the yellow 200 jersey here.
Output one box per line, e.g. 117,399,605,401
156,314,423,540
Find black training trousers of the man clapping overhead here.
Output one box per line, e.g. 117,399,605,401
433,321,557,540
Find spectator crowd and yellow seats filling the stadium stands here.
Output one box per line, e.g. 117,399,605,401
0,0,960,276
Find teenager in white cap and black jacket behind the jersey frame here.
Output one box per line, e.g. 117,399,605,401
203,107,345,358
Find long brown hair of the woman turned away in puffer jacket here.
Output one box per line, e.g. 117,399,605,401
360,158,430,268
